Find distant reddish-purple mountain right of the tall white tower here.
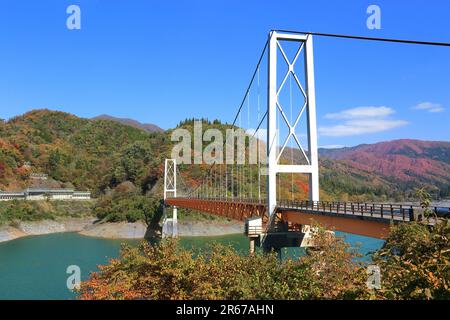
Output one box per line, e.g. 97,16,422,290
319,139,450,196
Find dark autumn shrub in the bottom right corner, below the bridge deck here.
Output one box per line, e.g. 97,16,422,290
374,220,450,299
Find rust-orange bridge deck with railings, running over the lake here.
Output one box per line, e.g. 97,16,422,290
166,198,450,238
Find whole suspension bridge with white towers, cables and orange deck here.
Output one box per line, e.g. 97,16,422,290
163,31,450,254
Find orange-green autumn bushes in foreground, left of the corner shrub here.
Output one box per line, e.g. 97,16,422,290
80,231,365,299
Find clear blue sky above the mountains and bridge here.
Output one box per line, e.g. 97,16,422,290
0,0,450,146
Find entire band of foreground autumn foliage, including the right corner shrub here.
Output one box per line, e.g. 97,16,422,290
79,221,450,300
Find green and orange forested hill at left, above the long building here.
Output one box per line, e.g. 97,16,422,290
0,110,170,195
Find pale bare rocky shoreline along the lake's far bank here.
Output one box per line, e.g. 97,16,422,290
0,218,243,242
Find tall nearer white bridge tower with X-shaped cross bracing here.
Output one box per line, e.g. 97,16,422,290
267,31,319,215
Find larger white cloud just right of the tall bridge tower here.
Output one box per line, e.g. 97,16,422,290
319,106,408,137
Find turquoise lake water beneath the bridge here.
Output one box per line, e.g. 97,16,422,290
0,233,383,299
